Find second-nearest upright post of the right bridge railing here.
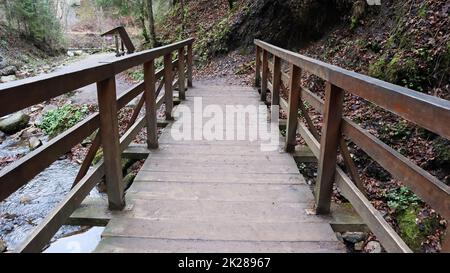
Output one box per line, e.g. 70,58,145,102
285,64,302,153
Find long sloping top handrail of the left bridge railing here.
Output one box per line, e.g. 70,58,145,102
0,39,193,116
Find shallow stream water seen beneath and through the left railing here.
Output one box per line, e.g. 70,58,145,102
0,139,101,252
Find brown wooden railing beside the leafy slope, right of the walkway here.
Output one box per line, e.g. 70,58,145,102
255,40,450,252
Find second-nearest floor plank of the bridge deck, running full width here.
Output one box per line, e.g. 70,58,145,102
103,218,336,242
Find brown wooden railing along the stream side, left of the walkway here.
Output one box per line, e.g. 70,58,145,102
0,39,193,252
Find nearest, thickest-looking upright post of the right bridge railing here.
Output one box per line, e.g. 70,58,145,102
316,82,344,214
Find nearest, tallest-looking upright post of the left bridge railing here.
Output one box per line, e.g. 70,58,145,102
97,77,125,210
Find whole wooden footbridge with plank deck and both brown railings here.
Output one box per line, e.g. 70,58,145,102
0,39,450,252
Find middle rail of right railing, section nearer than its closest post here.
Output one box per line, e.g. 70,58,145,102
342,118,450,219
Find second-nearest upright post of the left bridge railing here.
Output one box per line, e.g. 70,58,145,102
144,60,158,149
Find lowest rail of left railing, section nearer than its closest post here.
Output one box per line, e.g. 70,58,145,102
16,161,105,253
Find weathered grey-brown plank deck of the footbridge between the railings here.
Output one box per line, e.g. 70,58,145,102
96,82,344,252
